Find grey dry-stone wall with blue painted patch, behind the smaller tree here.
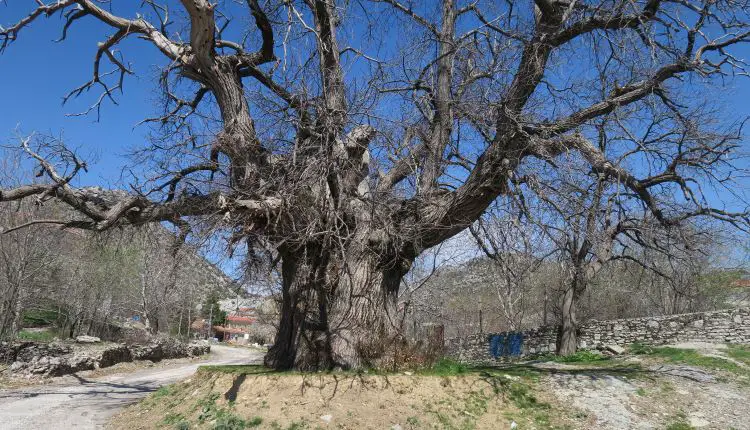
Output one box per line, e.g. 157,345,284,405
445,308,750,363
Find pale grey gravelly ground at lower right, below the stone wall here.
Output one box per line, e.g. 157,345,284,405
540,352,750,430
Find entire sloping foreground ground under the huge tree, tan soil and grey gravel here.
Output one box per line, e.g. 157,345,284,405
110,344,750,430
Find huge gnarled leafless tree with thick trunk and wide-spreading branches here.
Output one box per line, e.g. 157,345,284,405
0,0,750,368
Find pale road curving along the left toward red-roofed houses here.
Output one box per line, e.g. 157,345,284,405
0,345,263,430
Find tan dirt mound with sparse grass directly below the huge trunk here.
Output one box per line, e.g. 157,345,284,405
111,370,568,430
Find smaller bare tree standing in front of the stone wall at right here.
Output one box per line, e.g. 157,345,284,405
529,113,748,355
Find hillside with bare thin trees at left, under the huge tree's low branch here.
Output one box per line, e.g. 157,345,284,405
0,190,238,339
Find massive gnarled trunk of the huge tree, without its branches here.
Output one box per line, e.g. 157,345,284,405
265,247,409,370
